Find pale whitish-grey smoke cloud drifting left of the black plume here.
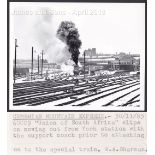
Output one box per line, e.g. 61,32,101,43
33,8,71,64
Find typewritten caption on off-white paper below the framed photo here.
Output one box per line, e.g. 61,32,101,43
8,112,147,155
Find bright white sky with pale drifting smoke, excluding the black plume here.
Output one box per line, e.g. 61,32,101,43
10,2,145,59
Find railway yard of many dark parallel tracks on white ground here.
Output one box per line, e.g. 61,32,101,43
13,74,140,110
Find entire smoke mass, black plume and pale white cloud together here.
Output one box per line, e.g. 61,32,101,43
30,8,81,75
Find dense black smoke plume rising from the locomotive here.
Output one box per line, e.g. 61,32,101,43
57,21,82,65
